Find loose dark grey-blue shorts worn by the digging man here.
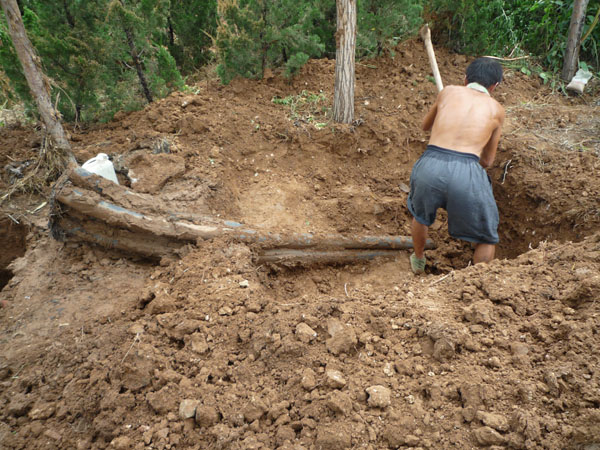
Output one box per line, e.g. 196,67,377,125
407,145,499,244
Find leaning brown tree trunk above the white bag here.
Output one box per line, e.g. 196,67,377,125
0,0,77,165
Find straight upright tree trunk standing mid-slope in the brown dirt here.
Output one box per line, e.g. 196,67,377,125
333,0,356,123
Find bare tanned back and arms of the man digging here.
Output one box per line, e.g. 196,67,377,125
423,86,504,168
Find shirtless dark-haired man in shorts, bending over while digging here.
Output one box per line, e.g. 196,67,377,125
408,58,504,273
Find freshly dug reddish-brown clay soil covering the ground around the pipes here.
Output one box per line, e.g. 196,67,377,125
0,42,600,450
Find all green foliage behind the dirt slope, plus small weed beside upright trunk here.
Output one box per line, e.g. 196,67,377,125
0,0,600,125
